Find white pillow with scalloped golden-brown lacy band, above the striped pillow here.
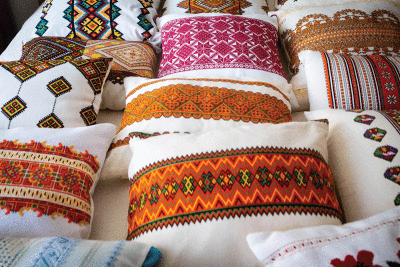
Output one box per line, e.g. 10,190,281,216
270,0,400,74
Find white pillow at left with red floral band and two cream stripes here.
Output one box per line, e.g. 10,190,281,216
0,124,115,238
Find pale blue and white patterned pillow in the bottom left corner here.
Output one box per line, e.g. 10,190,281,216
0,237,161,267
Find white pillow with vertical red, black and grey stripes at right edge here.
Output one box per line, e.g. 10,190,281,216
299,51,400,110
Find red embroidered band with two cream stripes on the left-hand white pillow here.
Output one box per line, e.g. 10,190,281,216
0,140,99,226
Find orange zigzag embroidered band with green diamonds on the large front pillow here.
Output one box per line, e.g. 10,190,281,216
127,147,343,240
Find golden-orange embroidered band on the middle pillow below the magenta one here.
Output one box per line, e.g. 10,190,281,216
120,81,291,134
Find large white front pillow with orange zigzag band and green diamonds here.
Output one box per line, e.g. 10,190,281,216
127,122,343,266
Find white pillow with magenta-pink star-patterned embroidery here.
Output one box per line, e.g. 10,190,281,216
158,14,287,83
